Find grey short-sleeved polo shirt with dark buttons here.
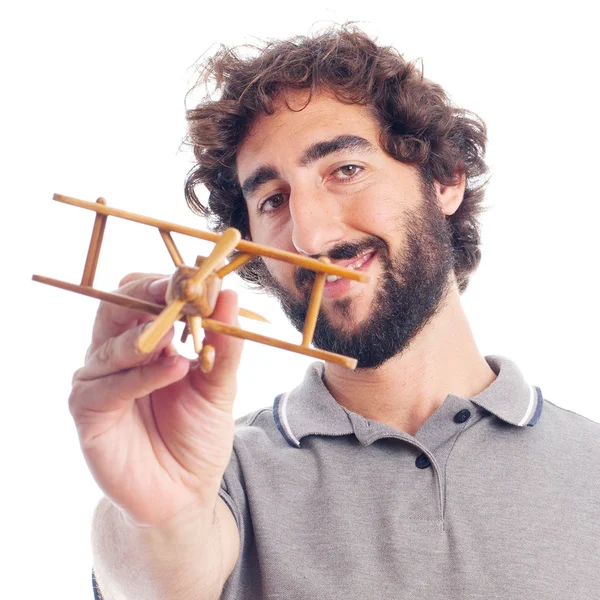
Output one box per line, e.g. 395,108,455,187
221,356,600,600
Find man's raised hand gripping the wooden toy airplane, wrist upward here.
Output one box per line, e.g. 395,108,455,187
69,274,243,525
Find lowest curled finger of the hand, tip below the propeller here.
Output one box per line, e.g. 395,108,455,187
69,356,190,420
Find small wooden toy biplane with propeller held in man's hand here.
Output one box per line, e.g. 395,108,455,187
32,194,369,372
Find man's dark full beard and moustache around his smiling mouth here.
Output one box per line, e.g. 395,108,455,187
254,188,453,369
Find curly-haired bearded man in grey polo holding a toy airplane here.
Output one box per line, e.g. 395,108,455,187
81,28,600,600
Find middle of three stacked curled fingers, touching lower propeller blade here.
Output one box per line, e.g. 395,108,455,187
73,324,175,380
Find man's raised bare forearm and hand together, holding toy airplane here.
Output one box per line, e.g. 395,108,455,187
69,273,243,600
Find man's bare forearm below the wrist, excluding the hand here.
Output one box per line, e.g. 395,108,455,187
92,498,240,600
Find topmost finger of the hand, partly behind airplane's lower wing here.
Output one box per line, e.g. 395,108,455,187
89,274,168,354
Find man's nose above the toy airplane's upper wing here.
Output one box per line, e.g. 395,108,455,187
289,185,344,256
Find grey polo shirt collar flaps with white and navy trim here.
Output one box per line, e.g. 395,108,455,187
273,356,543,447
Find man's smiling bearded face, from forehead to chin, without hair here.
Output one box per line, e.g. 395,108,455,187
237,92,452,368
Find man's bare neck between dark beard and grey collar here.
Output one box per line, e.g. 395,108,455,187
324,284,496,435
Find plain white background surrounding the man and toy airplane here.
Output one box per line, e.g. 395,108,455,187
0,0,600,599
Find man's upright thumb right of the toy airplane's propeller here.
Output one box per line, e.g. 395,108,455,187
191,290,244,401
